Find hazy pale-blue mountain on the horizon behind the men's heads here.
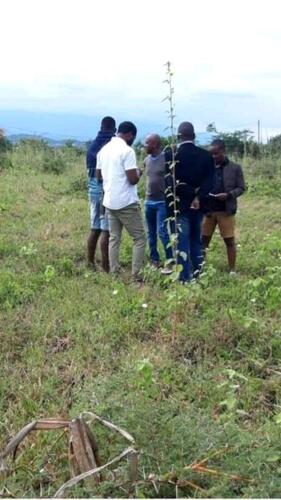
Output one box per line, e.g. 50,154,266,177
0,110,212,145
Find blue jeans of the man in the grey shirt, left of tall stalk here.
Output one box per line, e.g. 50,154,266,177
144,200,173,262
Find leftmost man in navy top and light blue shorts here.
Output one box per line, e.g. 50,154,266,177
86,116,116,272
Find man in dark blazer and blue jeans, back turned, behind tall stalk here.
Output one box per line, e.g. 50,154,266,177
166,122,214,282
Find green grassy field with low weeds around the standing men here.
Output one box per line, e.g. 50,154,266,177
0,148,281,498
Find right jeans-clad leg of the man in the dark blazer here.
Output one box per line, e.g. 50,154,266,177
189,210,204,277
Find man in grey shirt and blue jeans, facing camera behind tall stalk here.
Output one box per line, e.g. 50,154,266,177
144,134,173,267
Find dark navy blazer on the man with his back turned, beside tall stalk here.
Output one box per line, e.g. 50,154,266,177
166,142,214,216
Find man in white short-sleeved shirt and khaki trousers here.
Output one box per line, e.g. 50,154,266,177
96,122,146,279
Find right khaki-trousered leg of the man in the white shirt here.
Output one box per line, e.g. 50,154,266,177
117,203,146,277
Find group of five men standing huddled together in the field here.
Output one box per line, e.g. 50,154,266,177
87,117,245,282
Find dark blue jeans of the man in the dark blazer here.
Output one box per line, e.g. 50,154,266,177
172,209,203,281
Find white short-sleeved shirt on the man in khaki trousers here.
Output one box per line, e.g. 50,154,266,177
96,137,139,210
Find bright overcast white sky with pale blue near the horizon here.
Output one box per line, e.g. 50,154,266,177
0,0,281,135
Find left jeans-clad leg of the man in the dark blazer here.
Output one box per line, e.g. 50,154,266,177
177,215,191,282
